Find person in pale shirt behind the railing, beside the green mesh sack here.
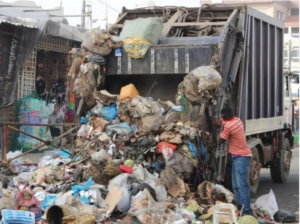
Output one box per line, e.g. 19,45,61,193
48,104,65,146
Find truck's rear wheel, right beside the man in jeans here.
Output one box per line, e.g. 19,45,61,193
249,147,261,196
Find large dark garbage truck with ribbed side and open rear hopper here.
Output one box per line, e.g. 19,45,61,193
105,5,293,194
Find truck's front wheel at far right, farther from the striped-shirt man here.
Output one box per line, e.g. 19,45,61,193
270,138,292,183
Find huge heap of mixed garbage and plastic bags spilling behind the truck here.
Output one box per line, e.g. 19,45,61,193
0,20,298,224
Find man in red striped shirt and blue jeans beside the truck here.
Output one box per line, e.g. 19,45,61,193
220,106,252,215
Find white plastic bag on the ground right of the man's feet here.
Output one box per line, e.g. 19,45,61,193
255,189,278,217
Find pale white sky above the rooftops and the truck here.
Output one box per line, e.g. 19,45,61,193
3,0,199,26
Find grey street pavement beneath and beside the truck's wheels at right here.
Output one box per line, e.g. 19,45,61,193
251,146,299,212
